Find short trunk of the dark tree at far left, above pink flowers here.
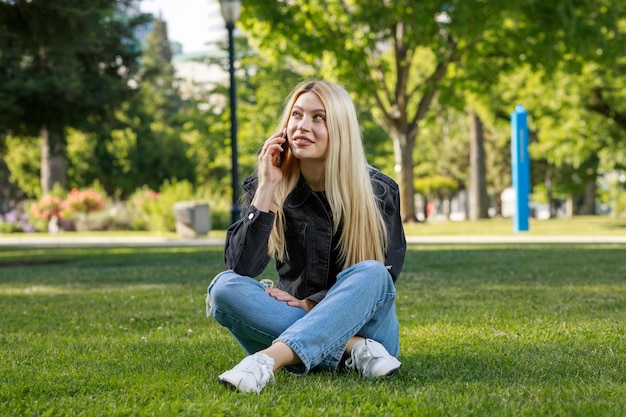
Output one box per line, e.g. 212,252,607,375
41,126,67,195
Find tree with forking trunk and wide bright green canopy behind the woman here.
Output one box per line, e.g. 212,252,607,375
241,0,616,221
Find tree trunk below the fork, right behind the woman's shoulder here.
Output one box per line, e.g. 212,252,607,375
393,133,417,223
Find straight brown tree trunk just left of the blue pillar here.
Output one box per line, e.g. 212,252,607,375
468,109,489,220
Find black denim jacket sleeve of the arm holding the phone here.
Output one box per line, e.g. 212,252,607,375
224,177,275,278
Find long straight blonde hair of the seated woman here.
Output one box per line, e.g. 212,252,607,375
268,81,387,269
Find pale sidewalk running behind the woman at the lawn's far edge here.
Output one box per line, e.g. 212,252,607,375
0,234,626,247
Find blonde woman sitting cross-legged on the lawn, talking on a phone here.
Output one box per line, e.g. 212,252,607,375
207,81,406,393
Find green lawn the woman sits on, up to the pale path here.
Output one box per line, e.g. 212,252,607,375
0,244,626,416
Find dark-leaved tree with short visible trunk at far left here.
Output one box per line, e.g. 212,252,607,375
0,0,146,194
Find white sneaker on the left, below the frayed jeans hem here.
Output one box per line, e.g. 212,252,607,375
219,353,274,394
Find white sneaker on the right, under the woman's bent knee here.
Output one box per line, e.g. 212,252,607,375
346,339,401,378
